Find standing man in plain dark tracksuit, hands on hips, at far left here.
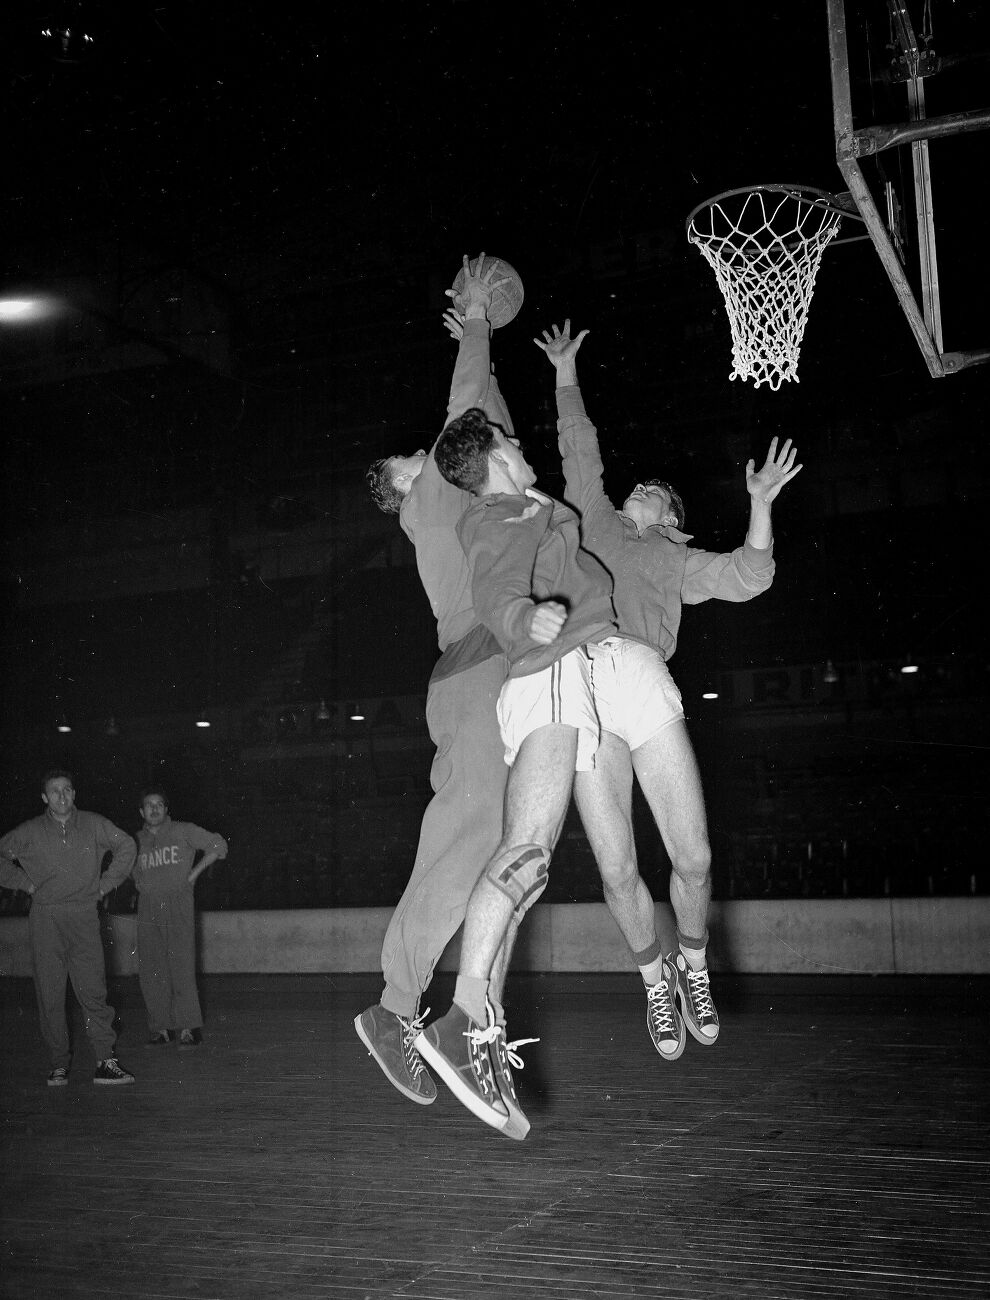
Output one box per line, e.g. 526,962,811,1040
0,770,135,1088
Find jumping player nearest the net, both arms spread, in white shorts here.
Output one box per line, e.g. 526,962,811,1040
534,321,802,1061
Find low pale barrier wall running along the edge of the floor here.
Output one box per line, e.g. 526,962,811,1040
0,897,990,975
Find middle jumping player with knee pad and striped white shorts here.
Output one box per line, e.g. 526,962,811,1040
416,358,616,1139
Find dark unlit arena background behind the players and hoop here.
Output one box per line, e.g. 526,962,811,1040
0,0,990,906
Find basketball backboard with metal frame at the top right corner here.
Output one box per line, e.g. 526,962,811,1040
828,0,990,378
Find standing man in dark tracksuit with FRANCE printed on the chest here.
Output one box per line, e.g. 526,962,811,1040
134,787,227,1048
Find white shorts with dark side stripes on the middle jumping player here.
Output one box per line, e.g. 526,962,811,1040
498,646,602,772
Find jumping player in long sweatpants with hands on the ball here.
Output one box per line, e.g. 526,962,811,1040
355,254,524,1105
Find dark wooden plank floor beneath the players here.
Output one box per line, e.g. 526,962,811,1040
0,974,990,1300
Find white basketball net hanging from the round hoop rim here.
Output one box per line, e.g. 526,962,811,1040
687,189,842,391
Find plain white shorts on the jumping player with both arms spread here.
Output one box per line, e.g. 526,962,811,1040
587,637,685,750
